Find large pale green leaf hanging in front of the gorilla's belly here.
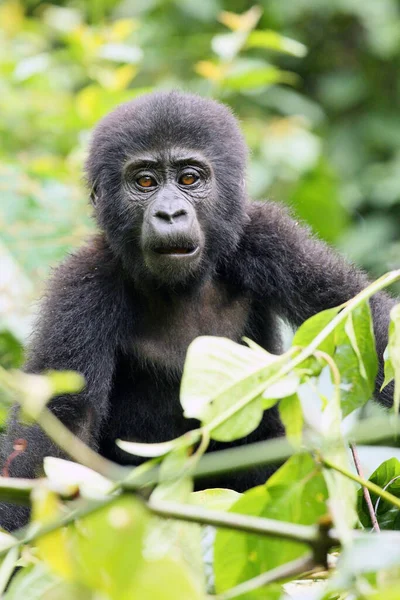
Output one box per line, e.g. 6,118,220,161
181,336,284,441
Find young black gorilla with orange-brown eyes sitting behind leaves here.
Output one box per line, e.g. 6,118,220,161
0,92,393,529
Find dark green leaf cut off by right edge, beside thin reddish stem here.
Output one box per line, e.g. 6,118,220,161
357,458,400,531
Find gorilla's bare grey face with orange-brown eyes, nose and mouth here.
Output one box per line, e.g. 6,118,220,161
123,149,214,283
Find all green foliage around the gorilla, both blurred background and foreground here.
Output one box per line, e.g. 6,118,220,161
0,0,400,600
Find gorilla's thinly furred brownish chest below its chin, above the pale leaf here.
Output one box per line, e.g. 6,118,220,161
133,283,250,372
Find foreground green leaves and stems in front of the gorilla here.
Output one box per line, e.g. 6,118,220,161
0,271,400,600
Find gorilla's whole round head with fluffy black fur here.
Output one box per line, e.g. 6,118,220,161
87,92,247,285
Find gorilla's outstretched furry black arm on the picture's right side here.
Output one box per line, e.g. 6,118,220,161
237,202,395,405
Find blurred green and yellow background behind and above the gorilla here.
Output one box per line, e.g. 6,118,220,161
0,0,400,366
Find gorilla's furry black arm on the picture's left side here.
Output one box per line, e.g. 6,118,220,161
0,243,122,506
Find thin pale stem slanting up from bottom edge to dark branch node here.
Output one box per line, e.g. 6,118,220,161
214,554,316,600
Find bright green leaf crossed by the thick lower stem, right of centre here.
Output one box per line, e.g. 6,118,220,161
214,454,327,593
